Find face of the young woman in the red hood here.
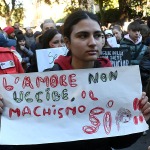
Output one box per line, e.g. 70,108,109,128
67,19,102,63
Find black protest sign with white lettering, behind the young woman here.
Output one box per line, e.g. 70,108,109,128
100,47,131,67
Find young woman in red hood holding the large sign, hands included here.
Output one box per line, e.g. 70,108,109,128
1,11,150,150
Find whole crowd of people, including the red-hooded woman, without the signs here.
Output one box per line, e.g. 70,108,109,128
0,10,150,150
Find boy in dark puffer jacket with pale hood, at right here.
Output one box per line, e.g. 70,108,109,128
120,21,148,65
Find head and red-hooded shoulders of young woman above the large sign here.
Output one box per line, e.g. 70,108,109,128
48,11,111,70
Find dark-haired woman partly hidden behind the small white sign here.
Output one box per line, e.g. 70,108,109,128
27,28,64,72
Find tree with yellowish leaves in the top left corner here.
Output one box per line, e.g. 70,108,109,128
0,0,24,26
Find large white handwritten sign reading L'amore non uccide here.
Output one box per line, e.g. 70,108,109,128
0,65,148,145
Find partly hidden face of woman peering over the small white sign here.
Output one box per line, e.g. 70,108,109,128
49,33,64,48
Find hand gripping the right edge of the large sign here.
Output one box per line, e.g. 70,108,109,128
140,92,150,121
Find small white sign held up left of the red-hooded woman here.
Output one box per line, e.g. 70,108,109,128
36,47,68,72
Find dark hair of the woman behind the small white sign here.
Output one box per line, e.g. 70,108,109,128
42,29,60,49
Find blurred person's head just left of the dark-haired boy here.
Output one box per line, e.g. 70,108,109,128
112,25,123,44
